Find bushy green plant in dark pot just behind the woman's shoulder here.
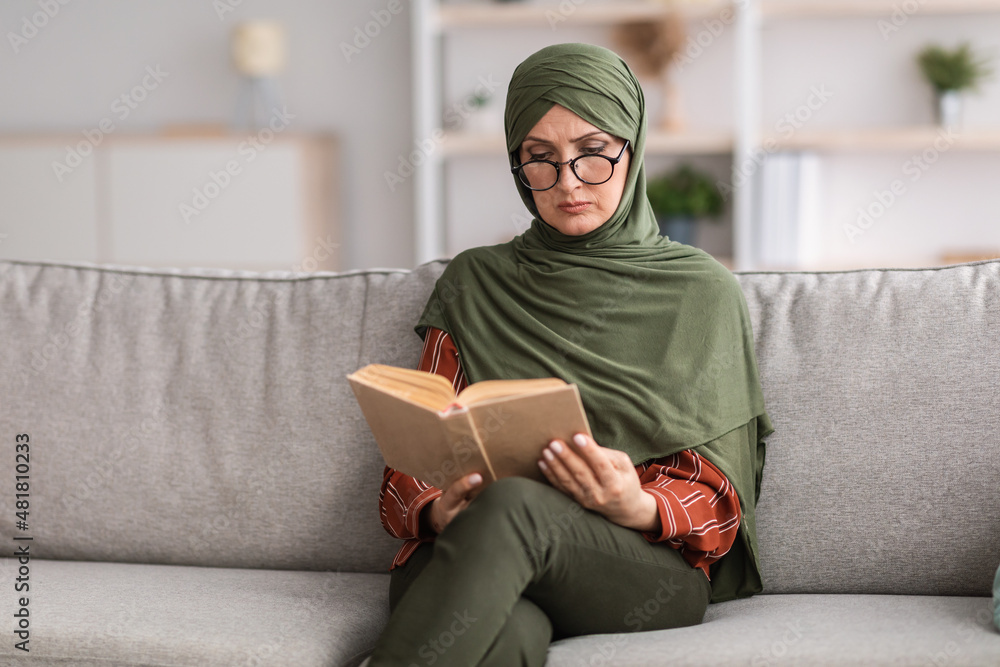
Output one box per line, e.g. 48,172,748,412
646,164,725,245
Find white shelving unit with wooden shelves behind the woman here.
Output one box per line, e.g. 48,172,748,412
412,0,1000,270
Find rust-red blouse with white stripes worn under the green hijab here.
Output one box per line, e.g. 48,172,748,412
379,327,740,576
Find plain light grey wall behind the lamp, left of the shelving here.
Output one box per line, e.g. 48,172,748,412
0,0,413,268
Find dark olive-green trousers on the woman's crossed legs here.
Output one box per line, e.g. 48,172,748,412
369,477,711,667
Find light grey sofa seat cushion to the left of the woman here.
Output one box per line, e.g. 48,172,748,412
0,559,389,667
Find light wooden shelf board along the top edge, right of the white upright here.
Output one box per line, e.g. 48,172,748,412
761,0,1000,19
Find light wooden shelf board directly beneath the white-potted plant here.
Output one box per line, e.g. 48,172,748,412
761,126,1000,152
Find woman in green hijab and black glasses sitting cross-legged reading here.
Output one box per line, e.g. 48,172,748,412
370,44,773,667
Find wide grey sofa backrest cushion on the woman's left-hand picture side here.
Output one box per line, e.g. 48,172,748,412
0,262,444,572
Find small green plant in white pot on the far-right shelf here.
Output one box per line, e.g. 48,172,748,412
917,42,993,128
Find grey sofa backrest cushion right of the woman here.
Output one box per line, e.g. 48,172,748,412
738,261,1000,595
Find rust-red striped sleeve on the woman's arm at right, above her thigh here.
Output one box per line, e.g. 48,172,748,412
636,450,740,574
